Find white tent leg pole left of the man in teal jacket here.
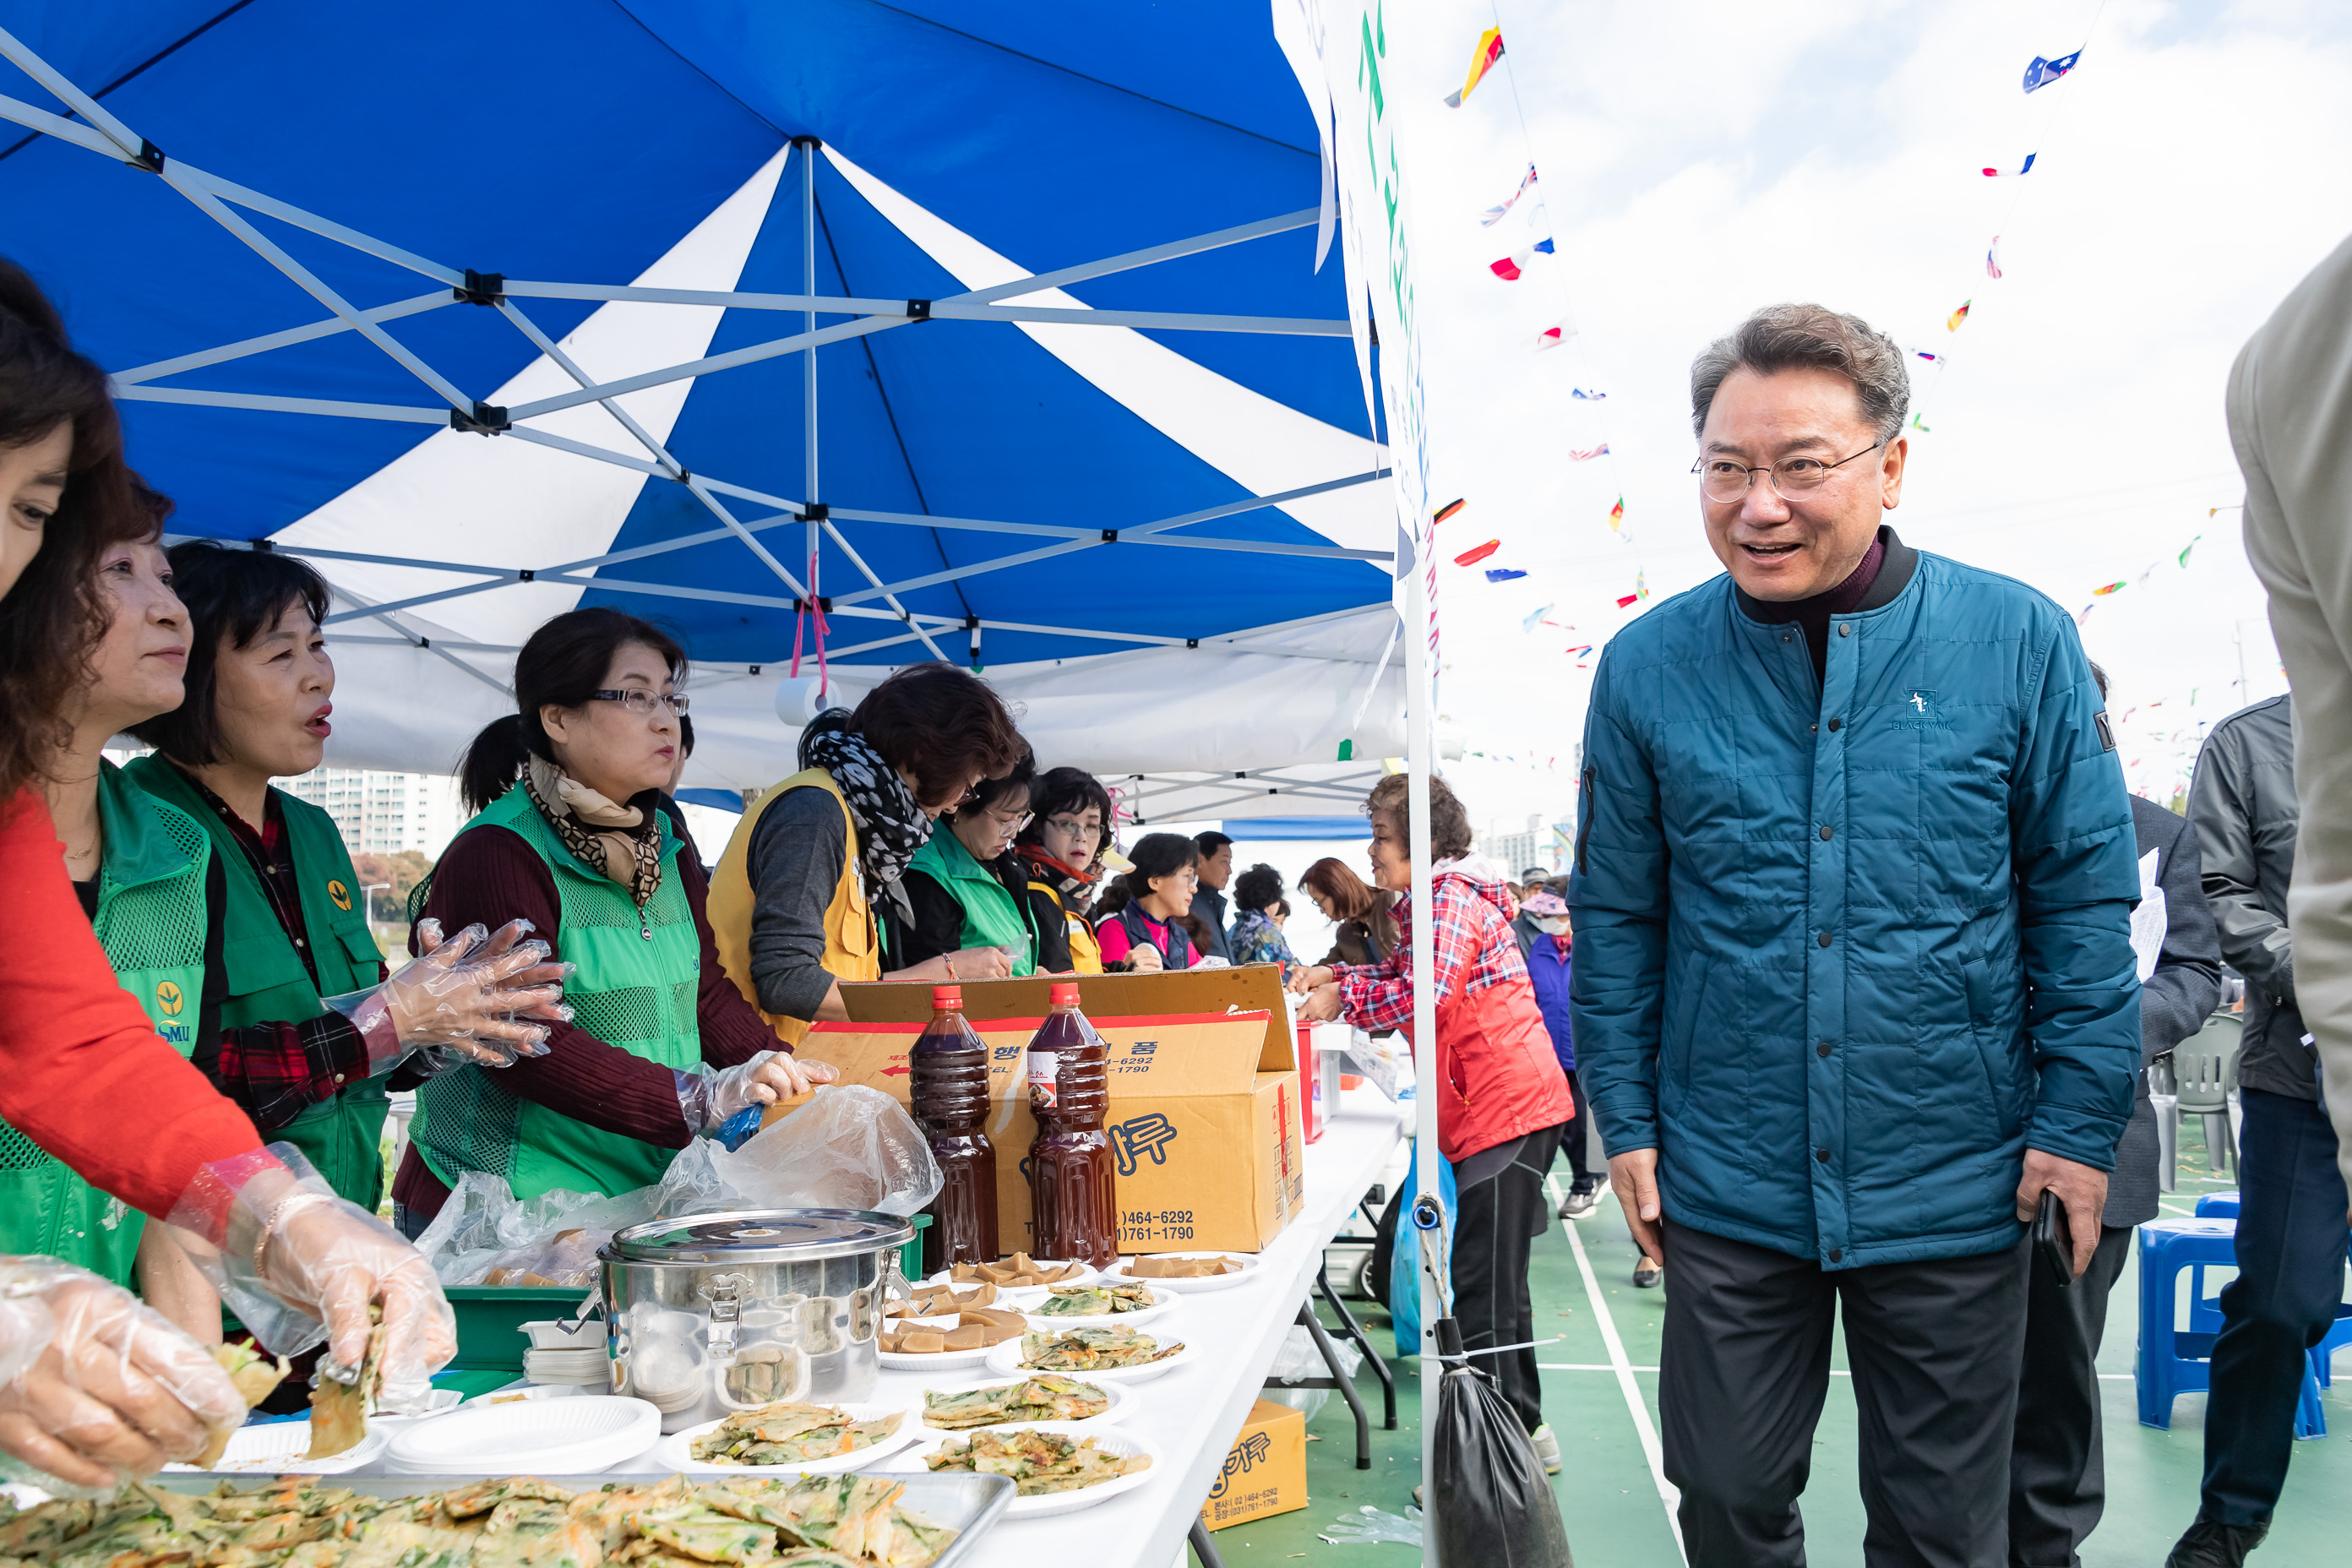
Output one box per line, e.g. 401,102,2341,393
1397,517,1454,1565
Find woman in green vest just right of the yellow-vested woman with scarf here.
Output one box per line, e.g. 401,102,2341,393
885,745,1040,976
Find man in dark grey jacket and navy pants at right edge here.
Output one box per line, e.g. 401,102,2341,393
2169,696,2345,1568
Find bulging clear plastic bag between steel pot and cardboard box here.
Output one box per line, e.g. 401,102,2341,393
656,1084,941,1216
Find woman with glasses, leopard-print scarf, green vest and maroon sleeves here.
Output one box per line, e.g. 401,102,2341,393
393,609,833,1237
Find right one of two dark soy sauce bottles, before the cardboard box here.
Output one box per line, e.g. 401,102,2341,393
1028,985,1119,1267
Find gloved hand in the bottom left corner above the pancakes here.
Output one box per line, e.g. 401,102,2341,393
0,1258,245,1490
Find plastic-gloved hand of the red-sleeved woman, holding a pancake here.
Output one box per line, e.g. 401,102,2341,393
172,1142,456,1411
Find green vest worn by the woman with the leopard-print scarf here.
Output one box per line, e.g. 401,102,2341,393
409,785,703,1199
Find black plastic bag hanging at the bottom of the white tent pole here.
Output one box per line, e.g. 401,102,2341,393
1430,1316,1576,1568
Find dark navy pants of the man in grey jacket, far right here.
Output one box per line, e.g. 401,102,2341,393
2197,1088,2345,1526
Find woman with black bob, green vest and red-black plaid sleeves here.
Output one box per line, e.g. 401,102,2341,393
122,541,571,1213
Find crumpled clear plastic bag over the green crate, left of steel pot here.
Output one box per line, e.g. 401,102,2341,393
416,1171,661,1291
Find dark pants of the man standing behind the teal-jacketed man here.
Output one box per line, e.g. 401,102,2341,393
2009,1225,2131,1568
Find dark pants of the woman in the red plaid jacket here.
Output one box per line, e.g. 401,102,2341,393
1454,1121,1573,1432
